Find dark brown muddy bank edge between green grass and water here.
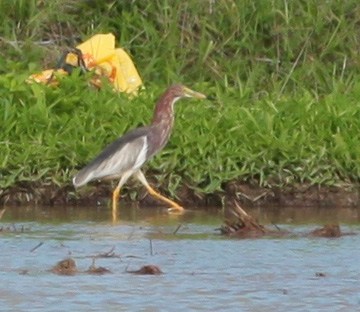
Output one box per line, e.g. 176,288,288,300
0,182,360,208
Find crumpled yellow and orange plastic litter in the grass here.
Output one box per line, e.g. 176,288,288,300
27,33,142,95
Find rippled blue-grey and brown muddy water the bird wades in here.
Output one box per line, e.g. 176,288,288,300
0,207,360,311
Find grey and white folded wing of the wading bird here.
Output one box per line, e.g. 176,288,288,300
73,127,148,187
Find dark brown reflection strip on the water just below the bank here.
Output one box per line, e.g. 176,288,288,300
1,205,360,225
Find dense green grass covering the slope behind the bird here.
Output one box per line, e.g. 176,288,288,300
0,0,360,202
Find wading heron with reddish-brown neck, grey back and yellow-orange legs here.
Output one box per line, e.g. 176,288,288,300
73,84,214,218
